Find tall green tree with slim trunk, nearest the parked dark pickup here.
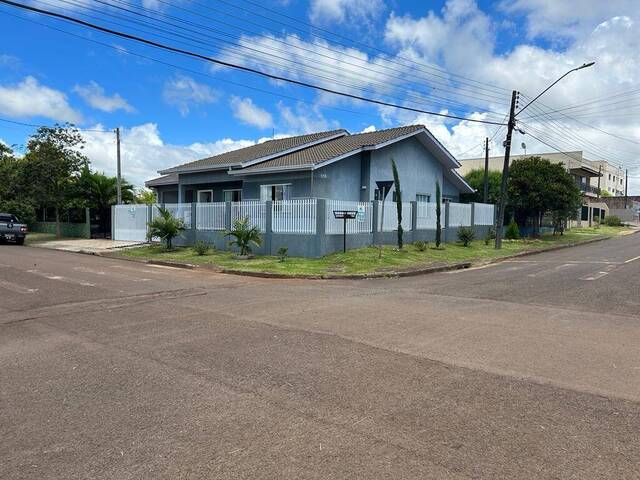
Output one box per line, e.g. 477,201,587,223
21,124,88,238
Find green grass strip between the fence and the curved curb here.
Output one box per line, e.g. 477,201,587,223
119,227,626,275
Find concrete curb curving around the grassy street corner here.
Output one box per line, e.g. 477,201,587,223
81,230,640,280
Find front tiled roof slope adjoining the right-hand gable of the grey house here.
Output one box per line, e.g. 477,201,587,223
232,125,424,175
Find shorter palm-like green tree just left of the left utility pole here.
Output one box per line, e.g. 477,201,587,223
74,166,135,233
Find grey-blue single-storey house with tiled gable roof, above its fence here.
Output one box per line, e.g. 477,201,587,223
146,125,473,203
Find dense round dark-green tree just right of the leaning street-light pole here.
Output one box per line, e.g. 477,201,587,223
509,157,581,234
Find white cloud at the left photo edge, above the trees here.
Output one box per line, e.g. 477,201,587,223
0,76,82,123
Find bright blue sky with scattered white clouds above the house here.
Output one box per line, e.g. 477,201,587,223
0,0,640,191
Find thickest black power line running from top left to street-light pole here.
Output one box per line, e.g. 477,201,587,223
0,0,508,125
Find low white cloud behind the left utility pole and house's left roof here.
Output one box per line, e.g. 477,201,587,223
82,123,256,186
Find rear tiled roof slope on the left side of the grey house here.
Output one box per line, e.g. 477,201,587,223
158,129,348,174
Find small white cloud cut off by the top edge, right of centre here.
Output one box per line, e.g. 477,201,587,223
309,0,385,26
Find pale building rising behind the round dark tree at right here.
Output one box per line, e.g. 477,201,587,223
458,150,625,197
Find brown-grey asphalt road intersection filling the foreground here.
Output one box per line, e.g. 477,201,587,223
0,235,640,480
